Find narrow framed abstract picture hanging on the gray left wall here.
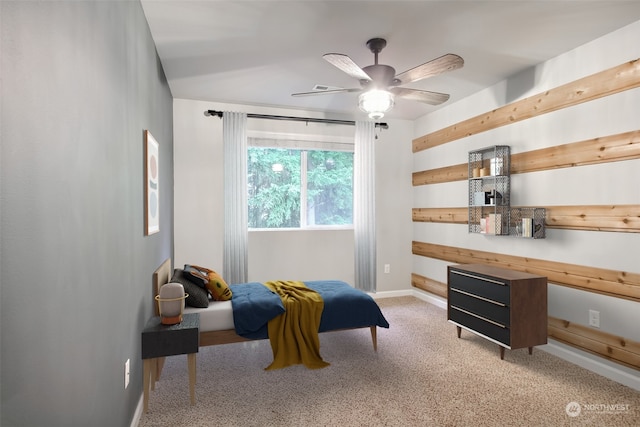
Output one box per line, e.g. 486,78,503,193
144,130,160,236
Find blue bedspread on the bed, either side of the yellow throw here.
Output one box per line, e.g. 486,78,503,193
230,280,389,339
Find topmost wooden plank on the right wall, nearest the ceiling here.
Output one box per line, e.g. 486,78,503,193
412,59,640,153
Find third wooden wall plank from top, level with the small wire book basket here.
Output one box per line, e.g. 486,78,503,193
411,205,640,233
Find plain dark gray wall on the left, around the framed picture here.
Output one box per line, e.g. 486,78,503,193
0,0,173,426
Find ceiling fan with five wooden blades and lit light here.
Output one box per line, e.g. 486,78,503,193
291,38,464,120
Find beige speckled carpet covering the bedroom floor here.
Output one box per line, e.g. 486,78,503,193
139,297,640,427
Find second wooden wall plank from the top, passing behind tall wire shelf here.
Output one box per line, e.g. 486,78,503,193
413,130,640,186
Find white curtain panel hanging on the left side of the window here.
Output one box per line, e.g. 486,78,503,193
222,111,249,284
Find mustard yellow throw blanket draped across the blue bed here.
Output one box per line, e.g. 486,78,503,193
265,281,329,370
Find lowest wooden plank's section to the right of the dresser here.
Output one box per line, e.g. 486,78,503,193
548,316,640,369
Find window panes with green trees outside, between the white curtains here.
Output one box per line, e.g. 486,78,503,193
247,147,353,228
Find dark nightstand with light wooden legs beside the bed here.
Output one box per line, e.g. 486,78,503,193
142,313,200,413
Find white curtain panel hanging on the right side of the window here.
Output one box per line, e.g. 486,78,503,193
353,121,376,292
